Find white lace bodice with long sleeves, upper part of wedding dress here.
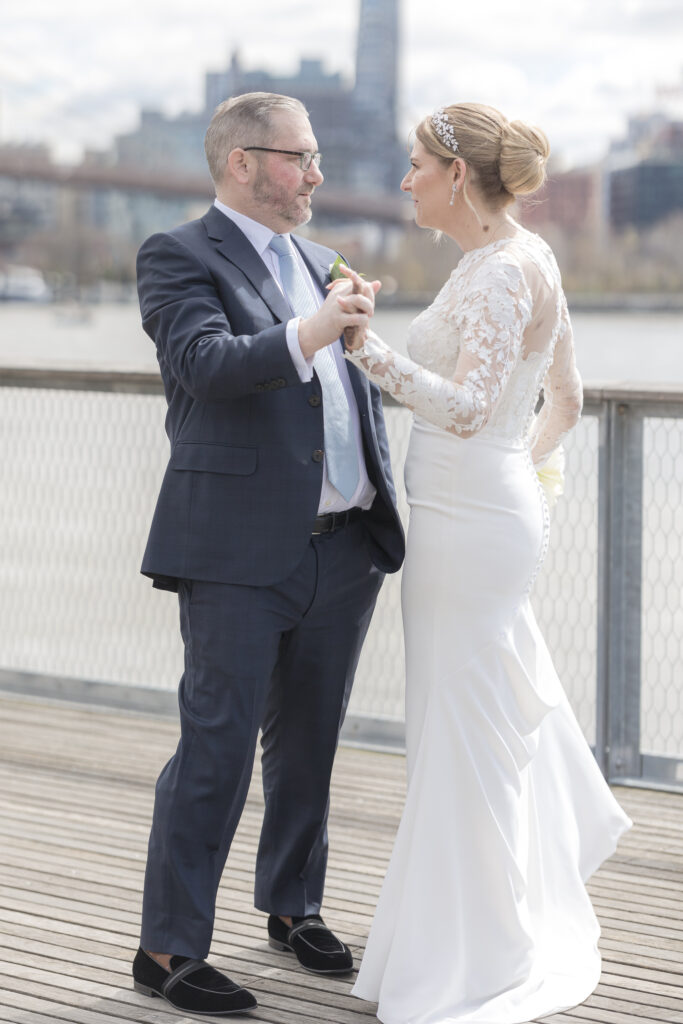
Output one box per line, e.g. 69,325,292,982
346,227,582,465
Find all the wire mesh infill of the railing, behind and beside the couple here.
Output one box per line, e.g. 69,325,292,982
0,387,683,770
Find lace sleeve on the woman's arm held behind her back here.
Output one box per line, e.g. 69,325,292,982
531,303,584,467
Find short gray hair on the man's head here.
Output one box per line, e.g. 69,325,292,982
204,92,308,184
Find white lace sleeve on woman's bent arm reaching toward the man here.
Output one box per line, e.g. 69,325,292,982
346,261,531,437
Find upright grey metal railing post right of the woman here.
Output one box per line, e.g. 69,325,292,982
596,399,643,780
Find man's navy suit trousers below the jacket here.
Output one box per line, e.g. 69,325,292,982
141,520,383,958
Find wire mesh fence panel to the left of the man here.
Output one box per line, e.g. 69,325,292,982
0,388,181,687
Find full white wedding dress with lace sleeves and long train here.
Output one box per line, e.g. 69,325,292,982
347,228,631,1024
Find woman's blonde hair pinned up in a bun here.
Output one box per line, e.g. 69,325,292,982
416,103,550,210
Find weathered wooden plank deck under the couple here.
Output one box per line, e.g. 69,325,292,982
0,695,683,1024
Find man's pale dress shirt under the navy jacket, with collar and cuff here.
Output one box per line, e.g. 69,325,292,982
214,200,377,513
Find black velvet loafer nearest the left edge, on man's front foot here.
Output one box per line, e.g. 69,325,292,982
133,948,256,1017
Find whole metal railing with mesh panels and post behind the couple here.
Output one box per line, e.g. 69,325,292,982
0,368,683,788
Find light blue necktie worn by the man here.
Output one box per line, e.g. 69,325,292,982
270,234,359,502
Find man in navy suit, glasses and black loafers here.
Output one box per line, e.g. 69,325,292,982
133,93,403,1016
